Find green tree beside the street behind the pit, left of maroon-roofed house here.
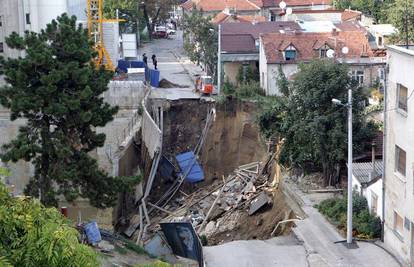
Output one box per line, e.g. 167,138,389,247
183,8,218,76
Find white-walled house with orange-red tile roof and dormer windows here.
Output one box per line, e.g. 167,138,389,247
259,23,385,95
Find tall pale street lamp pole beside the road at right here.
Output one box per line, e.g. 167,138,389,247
332,88,352,245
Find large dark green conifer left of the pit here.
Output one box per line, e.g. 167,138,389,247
0,14,136,208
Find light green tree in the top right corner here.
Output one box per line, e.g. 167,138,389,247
387,0,414,45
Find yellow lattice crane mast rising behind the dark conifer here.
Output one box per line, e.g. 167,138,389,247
87,0,115,71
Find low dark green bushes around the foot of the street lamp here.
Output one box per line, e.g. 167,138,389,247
316,193,381,239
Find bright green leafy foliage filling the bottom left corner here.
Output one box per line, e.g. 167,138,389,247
0,183,99,267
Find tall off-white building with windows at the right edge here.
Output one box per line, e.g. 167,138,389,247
384,46,414,266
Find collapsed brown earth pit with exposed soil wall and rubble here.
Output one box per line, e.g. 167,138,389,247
121,98,296,248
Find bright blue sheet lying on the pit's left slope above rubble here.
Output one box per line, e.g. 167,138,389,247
175,151,204,183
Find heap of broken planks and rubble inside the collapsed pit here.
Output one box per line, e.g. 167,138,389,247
149,158,285,245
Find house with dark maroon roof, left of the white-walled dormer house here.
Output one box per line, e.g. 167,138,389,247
221,21,300,84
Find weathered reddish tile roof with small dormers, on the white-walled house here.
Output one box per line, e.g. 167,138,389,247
262,31,373,64
